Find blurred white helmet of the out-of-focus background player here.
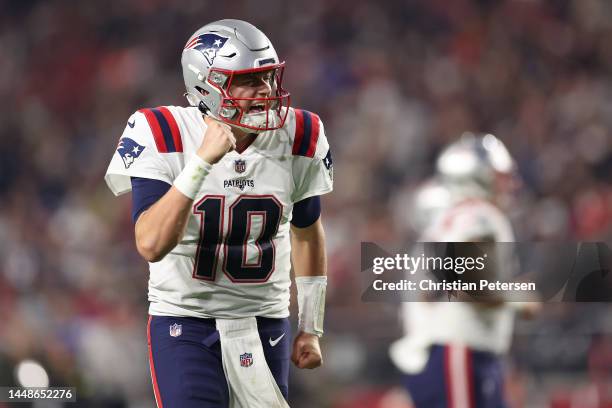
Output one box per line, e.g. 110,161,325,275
436,133,517,196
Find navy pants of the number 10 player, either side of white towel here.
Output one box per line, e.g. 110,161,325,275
147,316,291,408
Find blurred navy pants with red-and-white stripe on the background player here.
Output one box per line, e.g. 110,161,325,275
404,345,506,408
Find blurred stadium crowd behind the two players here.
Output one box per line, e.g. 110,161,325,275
0,0,612,408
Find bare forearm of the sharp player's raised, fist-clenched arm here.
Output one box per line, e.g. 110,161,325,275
136,187,193,262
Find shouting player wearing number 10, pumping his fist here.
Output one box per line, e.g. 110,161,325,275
105,20,332,408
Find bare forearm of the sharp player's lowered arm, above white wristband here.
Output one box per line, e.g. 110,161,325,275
291,218,327,277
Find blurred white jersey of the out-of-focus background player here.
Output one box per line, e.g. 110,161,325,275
394,199,514,364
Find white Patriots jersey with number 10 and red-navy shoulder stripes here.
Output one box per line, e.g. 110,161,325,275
105,106,333,318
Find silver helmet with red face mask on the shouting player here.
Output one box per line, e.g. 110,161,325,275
181,20,290,133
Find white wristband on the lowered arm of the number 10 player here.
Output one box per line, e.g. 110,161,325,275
295,276,327,337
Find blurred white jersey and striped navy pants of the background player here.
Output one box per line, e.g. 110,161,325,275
390,199,514,408
